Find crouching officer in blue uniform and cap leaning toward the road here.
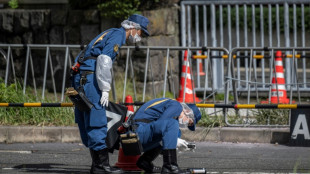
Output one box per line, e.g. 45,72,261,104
133,98,201,173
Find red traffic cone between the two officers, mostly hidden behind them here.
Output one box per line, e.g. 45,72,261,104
115,95,141,171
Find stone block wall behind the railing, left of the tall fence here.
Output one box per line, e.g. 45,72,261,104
0,5,180,96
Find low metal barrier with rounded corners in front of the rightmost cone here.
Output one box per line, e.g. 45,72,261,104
225,47,310,126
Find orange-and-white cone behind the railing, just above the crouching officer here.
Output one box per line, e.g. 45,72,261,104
177,50,200,103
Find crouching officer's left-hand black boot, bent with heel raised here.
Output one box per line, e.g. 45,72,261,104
137,146,162,173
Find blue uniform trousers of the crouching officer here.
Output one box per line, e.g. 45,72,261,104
136,118,179,151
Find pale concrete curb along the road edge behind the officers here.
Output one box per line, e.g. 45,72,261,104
0,126,290,144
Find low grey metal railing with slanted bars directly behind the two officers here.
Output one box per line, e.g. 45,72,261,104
0,44,229,105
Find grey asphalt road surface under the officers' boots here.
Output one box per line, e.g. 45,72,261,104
0,142,310,174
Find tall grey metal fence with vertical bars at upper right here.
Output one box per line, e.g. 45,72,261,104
181,0,310,94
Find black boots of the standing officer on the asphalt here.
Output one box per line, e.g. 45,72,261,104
90,149,123,174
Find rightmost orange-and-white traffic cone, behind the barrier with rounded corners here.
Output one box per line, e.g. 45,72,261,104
262,51,295,104
